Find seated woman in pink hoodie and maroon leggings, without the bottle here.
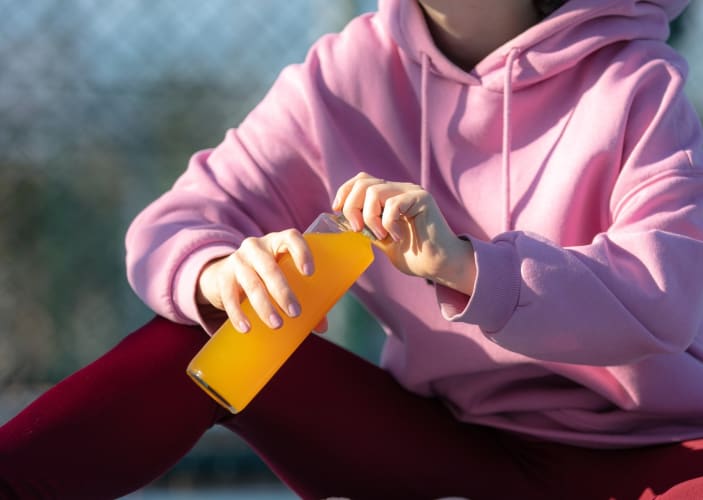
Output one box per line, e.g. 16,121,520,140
0,0,703,499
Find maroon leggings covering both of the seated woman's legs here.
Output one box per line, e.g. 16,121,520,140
0,318,703,500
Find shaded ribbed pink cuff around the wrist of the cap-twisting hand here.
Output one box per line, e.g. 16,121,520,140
435,237,520,334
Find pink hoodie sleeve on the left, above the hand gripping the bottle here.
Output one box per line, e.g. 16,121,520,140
126,46,346,331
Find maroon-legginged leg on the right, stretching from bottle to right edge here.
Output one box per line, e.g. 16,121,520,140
220,336,703,500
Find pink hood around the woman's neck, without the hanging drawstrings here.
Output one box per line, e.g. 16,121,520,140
379,0,689,91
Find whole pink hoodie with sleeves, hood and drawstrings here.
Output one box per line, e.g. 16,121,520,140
127,0,703,447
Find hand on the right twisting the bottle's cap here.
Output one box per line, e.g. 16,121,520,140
332,172,476,295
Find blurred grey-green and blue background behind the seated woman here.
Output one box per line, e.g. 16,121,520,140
0,0,703,498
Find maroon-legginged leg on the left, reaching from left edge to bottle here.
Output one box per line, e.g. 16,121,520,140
0,318,217,499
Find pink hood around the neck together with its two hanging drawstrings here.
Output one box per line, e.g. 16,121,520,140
379,0,688,231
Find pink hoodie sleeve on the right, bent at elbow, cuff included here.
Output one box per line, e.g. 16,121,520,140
437,50,703,365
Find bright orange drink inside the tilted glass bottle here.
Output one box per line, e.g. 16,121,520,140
187,215,373,413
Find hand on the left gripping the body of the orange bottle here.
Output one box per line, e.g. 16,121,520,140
196,229,327,333
